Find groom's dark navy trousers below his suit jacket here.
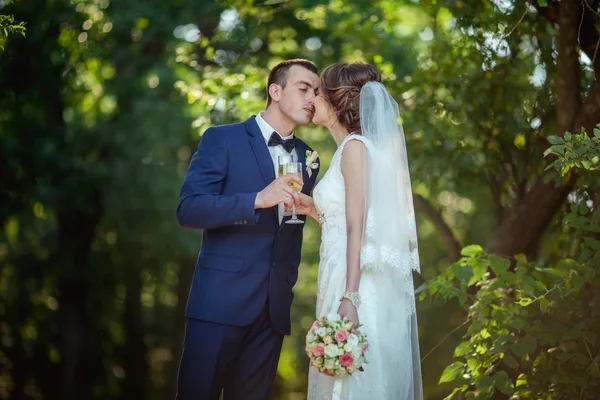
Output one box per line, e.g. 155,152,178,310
177,302,283,400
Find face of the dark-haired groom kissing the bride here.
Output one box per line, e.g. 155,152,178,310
279,65,319,125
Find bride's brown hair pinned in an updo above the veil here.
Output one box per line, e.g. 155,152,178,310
321,63,381,133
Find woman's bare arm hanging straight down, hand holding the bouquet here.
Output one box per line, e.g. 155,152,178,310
340,140,368,322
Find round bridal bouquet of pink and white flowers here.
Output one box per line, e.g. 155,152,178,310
305,313,369,376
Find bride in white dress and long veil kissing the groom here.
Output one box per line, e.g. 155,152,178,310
298,63,423,400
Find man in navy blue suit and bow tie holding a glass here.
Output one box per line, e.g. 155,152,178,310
177,59,319,400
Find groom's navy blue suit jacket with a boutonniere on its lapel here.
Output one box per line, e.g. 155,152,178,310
177,117,318,335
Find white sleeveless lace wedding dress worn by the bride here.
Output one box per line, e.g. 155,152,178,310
308,135,423,400
